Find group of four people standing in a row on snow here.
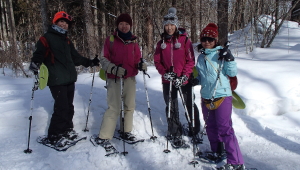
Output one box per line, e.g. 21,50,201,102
30,8,245,170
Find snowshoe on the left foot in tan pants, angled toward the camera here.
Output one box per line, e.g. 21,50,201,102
90,134,119,156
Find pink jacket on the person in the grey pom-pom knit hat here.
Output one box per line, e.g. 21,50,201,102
154,29,195,84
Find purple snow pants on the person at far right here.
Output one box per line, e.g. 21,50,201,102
201,96,244,165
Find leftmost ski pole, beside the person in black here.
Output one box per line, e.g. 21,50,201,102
24,74,39,153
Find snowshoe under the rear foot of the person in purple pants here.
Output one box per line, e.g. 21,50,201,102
196,152,227,164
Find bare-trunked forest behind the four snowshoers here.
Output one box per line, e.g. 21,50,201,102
0,0,300,77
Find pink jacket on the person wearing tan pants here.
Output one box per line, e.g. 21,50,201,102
103,32,141,78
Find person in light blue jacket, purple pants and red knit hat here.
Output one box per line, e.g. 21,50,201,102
196,23,245,170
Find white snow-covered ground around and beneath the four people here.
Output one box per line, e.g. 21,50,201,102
0,18,300,170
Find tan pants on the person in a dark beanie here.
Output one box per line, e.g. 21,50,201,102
99,77,136,139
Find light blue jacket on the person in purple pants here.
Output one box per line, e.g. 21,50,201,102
196,46,237,99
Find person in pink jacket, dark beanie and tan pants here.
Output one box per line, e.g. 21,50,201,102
95,14,147,148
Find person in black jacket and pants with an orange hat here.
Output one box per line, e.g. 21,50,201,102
29,11,99,147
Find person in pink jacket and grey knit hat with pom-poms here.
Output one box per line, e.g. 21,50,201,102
154,7,200,147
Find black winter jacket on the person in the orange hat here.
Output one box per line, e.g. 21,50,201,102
31,26,92,86
